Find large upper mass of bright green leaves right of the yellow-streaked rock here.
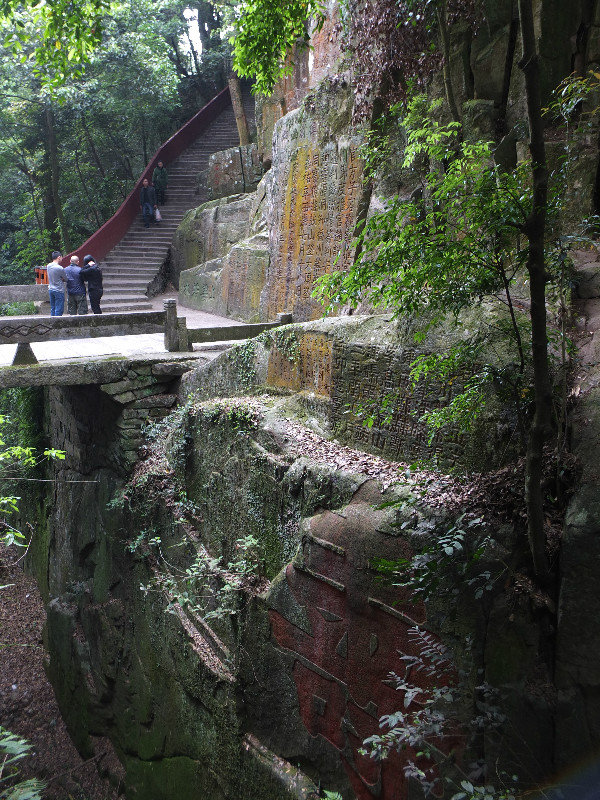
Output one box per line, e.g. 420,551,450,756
318,98,544,328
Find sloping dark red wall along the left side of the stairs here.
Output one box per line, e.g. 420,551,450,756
62,88,230,264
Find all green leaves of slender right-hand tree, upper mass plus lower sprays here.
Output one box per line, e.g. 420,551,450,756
314,96,562,440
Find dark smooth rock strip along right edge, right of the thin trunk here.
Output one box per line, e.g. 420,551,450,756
556,248,600,780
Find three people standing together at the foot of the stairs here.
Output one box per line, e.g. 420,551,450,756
46,250,103,317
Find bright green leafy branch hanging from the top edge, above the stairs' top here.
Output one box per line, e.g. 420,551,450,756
233,0,324,95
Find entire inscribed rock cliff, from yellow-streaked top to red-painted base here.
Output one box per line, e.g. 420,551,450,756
22,0,600,800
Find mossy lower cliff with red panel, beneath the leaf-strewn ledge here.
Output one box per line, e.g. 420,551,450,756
27,346,550,800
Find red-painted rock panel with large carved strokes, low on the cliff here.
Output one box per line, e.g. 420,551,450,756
270,485,456,800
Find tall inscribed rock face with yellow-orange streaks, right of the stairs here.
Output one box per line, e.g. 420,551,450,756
178,84,365,322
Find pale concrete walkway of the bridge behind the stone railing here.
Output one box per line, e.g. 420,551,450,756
0,290,243,367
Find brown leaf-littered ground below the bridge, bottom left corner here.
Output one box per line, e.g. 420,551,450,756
0,559,118,800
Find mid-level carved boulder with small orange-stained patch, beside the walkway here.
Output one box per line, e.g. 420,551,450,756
183,316,515,469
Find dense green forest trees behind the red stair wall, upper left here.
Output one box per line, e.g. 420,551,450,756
0,0,229,284
